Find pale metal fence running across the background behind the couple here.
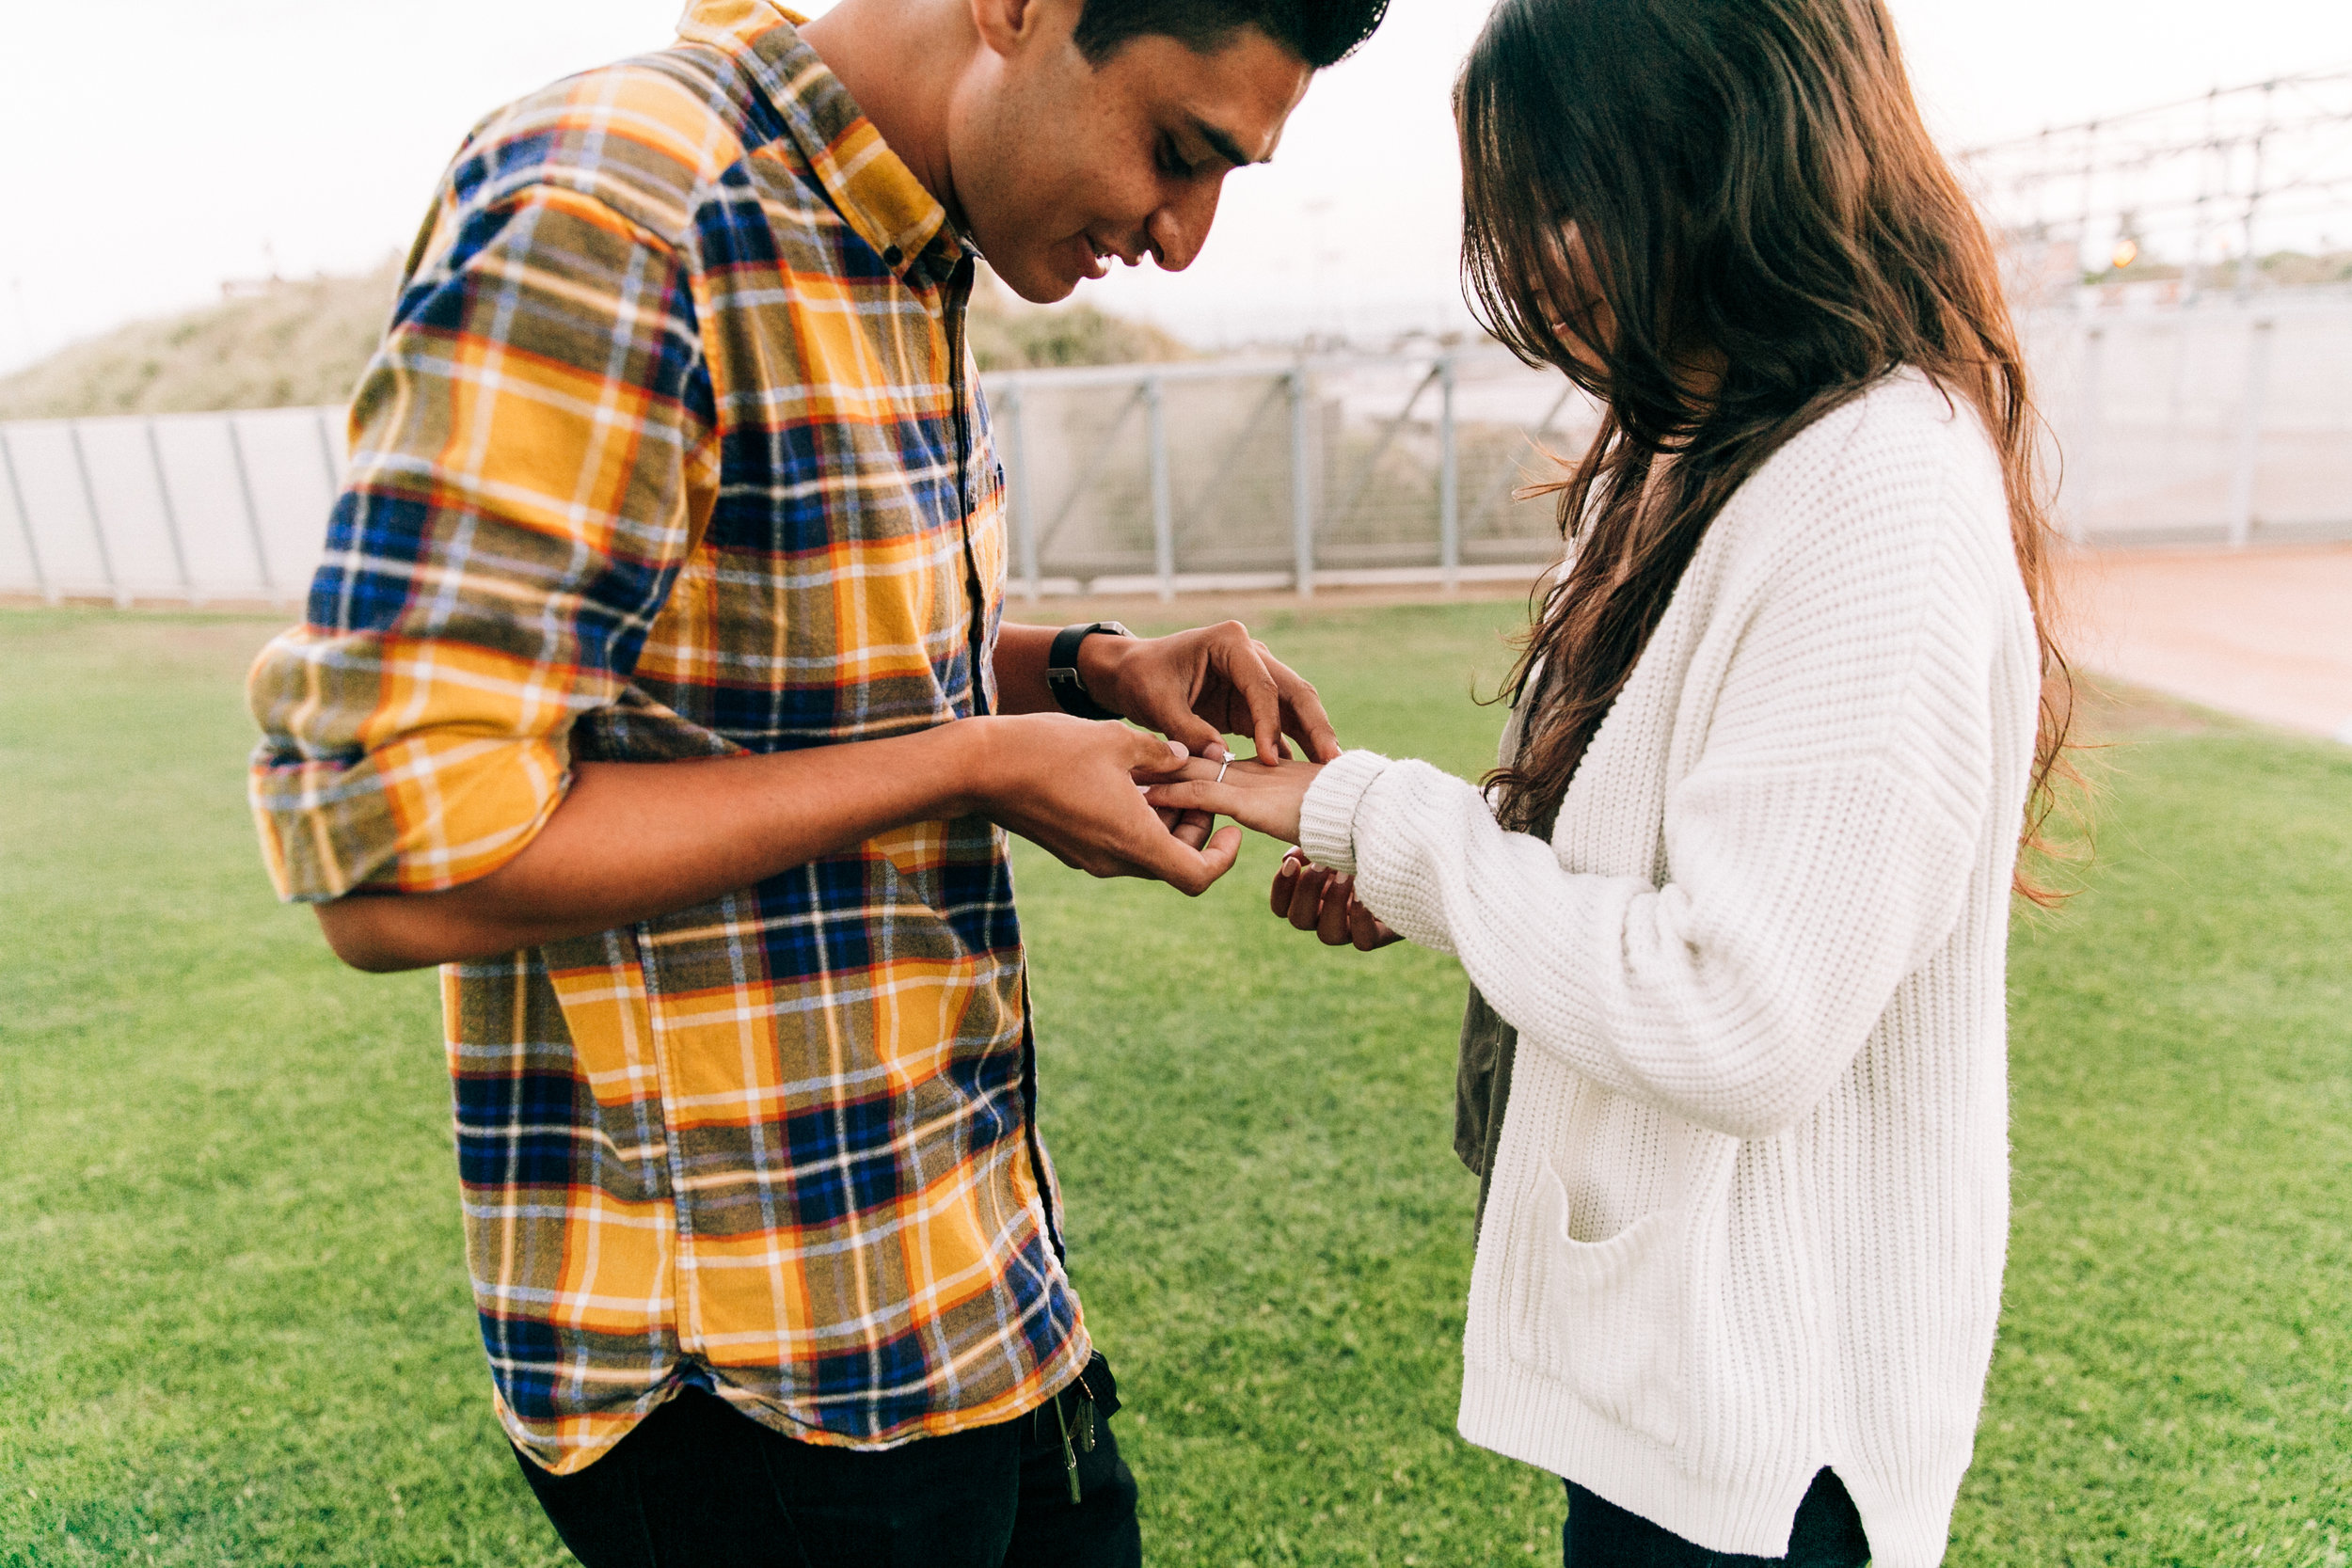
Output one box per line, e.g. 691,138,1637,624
0,317,2352,604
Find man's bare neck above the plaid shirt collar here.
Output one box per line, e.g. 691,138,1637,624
800,0,981,228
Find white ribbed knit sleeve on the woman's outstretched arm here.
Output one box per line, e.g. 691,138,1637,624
1303,404,2013,1138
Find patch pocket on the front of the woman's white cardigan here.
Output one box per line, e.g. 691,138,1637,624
1515,1157,1684,1444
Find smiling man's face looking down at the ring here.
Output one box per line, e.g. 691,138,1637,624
948,0,1315,303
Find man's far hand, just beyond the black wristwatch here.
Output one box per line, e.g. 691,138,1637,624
1077,621,1339,762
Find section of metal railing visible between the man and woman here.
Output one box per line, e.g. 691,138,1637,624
983,350,1595,599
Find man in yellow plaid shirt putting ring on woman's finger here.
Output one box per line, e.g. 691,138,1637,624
252,0,1386,1568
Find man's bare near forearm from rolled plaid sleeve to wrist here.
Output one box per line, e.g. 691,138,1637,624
318,728,983,971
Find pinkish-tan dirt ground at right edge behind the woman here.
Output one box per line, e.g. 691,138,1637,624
2065,546,2352,740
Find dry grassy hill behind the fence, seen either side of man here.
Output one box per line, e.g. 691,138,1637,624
0,263,1190,419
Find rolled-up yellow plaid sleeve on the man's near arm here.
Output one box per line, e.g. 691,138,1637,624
247,176,718,903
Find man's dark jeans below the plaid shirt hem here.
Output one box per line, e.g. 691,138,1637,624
516,1389,1143,1568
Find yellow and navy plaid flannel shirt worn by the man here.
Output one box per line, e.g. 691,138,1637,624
252,0,1089,1472
